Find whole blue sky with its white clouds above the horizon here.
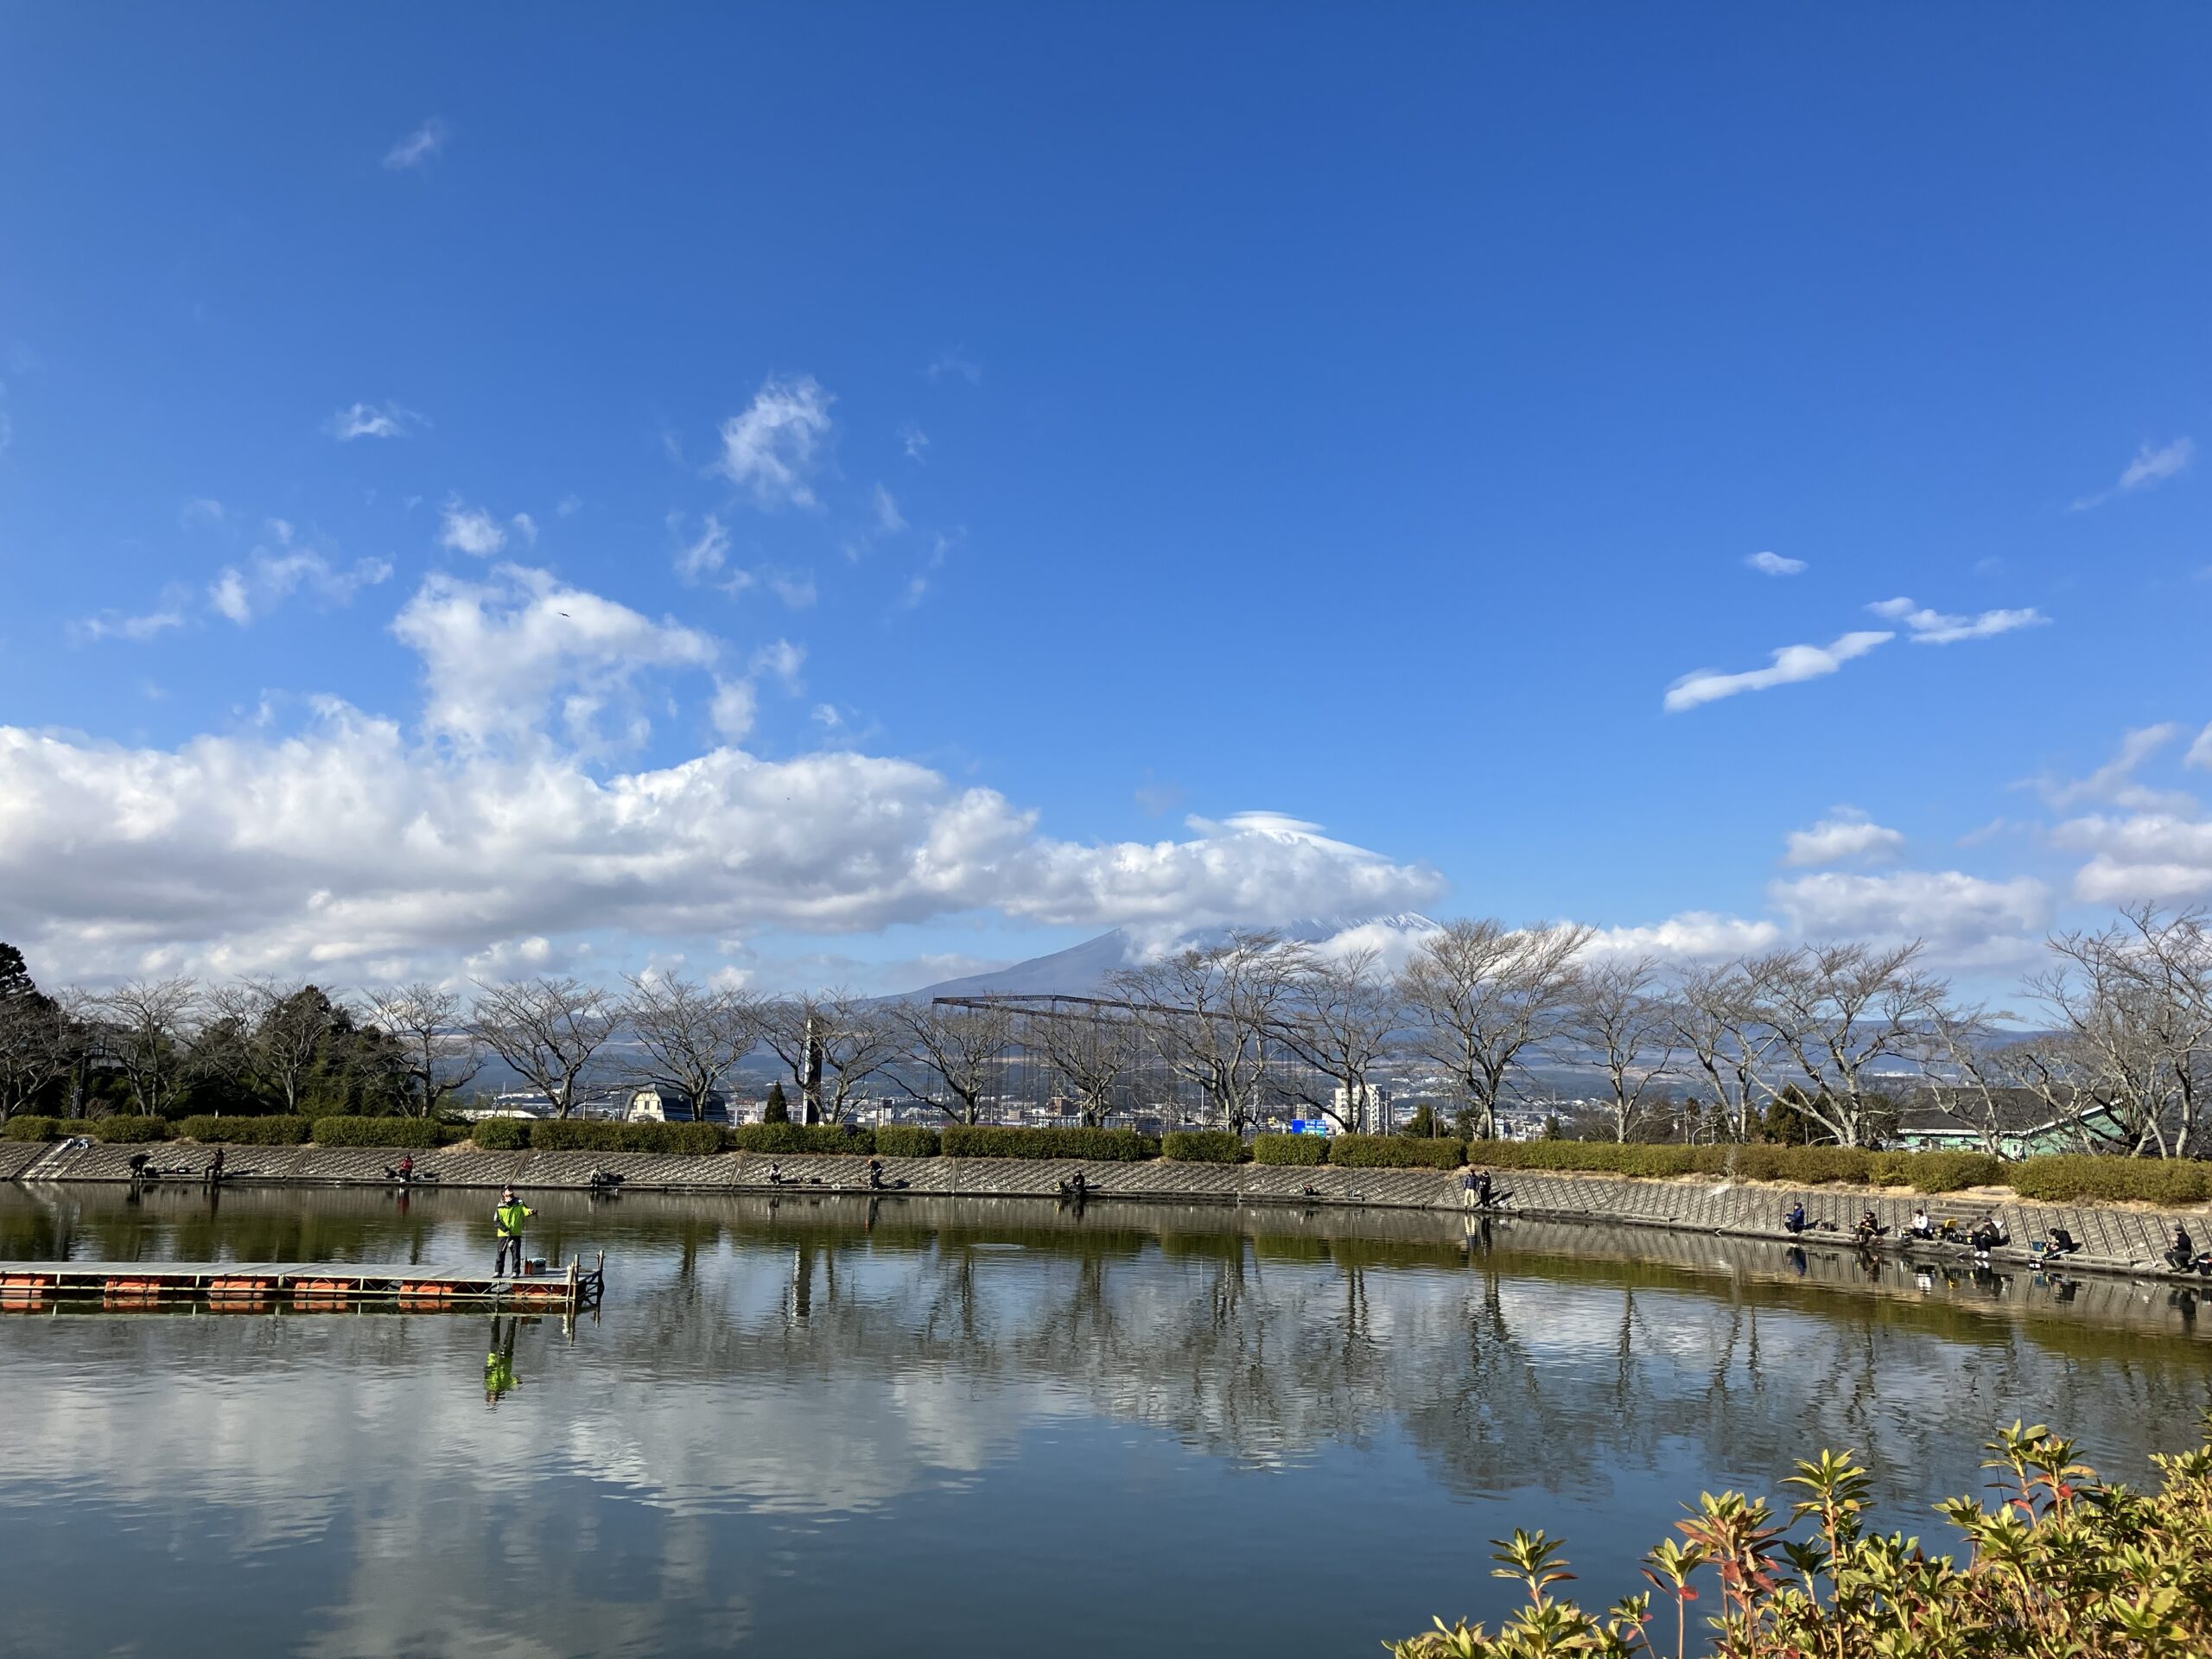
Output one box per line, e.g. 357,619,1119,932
0,7,2212,988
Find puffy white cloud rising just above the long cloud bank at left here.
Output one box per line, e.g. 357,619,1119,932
391,564,721,750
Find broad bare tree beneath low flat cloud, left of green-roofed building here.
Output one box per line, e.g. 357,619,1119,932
1758,940,1948,1146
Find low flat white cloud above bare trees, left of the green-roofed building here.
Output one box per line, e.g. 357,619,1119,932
1767,869,2050,963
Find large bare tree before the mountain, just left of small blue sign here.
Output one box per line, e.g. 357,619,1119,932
1110,929,1307,1133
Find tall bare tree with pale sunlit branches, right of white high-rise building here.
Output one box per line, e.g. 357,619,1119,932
1398,920,1591,1139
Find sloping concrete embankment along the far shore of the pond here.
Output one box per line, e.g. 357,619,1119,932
0,1141,2212,1274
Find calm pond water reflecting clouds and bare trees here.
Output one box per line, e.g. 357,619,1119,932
0,1188,2212,1659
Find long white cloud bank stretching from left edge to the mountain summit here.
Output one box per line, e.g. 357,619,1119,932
0,721,1440,978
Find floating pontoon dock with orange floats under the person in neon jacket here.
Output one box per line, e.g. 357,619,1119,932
0,1255,606,1314
